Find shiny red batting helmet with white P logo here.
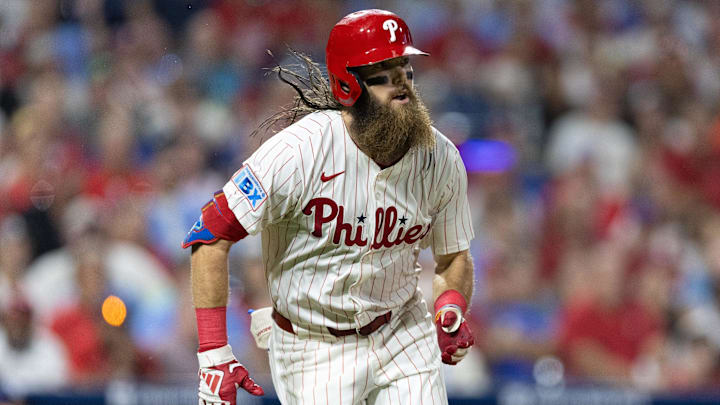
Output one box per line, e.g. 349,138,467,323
325,9,427,107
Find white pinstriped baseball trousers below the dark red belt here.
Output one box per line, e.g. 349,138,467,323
269,296,447,405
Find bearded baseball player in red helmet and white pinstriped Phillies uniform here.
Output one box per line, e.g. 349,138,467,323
184,10,474,405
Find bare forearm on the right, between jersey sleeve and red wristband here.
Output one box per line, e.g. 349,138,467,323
433,250,475,303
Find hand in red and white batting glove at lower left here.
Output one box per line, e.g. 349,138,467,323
198,345,265,405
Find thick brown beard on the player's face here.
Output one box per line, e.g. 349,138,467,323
349,87,435,164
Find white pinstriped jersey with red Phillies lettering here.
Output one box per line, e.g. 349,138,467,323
223,111,473,333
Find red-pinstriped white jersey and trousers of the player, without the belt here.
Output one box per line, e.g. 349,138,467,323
223,112,473,404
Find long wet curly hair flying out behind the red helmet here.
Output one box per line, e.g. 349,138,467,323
250,48,343,136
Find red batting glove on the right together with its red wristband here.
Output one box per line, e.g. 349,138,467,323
435,290,475,365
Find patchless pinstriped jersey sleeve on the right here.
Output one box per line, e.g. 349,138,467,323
429,147,474,255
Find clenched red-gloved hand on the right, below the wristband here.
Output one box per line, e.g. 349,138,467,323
435,305,475,365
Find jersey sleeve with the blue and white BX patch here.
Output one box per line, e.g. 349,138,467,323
223,134,302,235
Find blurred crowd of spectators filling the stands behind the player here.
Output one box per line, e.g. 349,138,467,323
0,0,720,402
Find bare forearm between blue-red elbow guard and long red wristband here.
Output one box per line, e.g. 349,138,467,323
190,239,232,308
